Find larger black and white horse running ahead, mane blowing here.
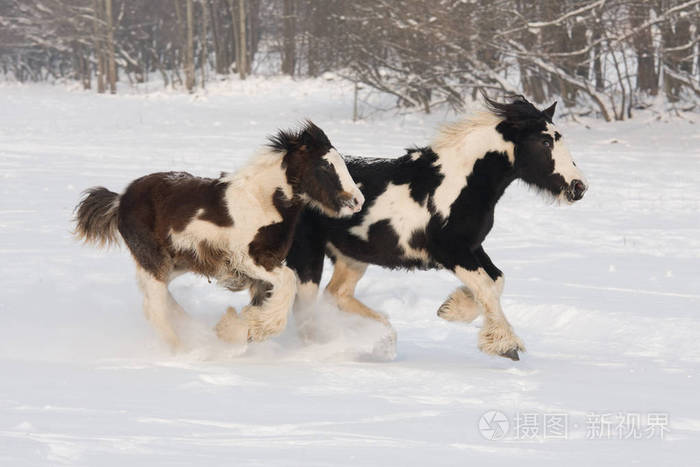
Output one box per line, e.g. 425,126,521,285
287,97,587,360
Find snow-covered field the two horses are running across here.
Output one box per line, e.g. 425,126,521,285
0,79,700,466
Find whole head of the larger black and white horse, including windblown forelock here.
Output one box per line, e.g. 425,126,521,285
484,96,588,203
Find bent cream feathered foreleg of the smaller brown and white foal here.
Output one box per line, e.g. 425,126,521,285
216,264,296,343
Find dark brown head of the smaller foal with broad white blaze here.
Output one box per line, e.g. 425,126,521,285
270,122,365,217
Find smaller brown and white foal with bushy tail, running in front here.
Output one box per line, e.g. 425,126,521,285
76,122,364,348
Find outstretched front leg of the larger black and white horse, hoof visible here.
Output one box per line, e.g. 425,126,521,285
453,247,525,360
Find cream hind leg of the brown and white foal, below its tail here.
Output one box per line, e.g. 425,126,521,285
136,266,181,349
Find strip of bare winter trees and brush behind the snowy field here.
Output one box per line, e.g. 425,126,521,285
0,0,700,121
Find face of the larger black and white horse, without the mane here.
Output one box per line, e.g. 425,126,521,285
515,103,588,203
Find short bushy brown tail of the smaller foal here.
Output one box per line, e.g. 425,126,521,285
74,186,119,246
